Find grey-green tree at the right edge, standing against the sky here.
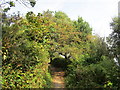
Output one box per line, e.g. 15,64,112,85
108,17,120,65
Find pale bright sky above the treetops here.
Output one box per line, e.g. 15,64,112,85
6,0,119,37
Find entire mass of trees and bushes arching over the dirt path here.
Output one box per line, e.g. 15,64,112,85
2,10,120,88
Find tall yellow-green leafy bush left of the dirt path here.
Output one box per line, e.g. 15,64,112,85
2,11,51,88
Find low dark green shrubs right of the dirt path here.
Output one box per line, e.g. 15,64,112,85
66,56,120,88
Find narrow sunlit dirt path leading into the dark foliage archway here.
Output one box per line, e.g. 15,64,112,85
51,67,65,88
